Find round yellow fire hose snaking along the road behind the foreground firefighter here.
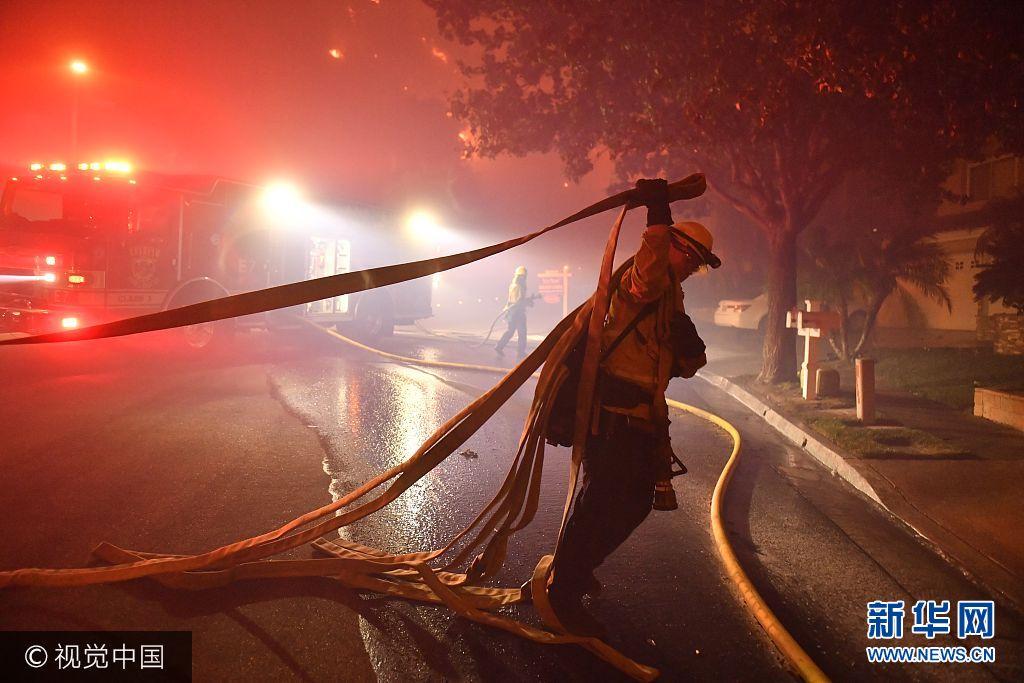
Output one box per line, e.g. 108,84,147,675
302,318,828,683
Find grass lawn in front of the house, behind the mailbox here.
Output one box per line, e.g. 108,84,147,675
827,348,1024,410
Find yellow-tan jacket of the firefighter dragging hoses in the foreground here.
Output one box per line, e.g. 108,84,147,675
601,225,685,422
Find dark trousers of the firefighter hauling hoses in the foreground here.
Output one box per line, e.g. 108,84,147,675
551,421,657,595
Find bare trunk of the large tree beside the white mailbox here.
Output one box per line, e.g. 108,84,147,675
758,229,797,384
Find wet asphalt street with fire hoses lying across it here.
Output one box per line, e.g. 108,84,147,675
0,333,1024,681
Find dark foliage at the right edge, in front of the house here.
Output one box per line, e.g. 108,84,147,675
974,197,1024,314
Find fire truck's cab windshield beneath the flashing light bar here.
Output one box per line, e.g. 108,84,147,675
3,186,131,232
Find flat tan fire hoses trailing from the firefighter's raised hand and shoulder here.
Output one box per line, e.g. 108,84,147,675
0,174,820,681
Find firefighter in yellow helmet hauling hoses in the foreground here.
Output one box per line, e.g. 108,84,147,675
549,179,721,637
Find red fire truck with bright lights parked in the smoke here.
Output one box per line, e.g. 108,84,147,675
0,161,431,348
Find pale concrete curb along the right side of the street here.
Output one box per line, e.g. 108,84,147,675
696,370,1024,614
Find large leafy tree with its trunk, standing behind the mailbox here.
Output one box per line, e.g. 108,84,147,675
427,0,1024,382
